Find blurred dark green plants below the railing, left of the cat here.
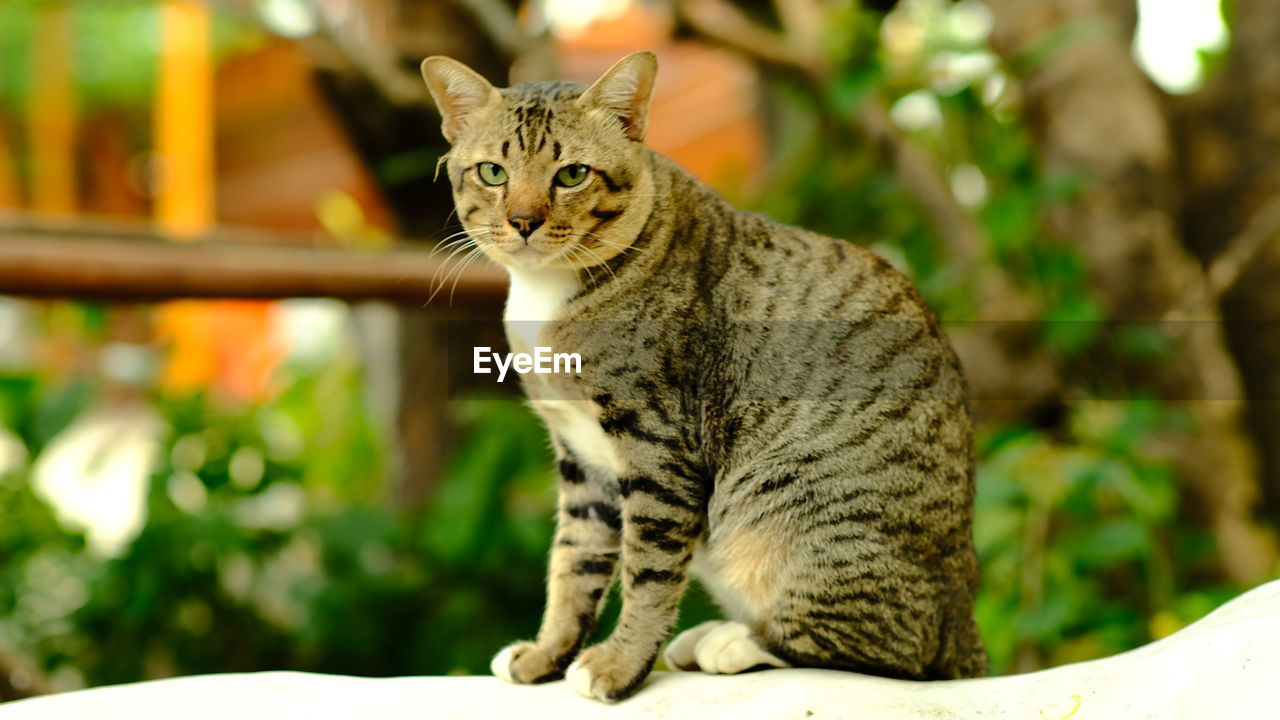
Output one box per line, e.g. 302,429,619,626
0,295,554,688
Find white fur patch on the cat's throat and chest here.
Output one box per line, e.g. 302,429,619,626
502,268,622,477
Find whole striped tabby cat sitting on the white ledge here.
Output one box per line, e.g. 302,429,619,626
421,53,987,702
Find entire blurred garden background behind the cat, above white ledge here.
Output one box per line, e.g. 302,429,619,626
0,0,1280,700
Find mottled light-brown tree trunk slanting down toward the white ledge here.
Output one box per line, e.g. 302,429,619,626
989,0,1275,584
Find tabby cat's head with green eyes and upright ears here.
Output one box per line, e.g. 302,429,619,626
422,53,658,269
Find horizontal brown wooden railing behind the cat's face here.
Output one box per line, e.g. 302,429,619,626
0,217,507,302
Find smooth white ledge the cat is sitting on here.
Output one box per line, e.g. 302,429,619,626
0,582,1280,720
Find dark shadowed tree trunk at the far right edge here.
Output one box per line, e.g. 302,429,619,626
1174,0,1280,518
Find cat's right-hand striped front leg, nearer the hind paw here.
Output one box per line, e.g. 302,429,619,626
566,461,707,702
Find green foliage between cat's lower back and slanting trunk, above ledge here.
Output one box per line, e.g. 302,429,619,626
974,400,1234,671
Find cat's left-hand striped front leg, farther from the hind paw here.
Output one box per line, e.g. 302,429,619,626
489,452,622,683
